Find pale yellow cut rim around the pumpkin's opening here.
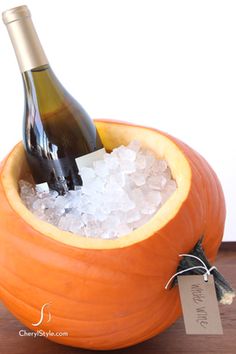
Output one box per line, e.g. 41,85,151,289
0,119,192,250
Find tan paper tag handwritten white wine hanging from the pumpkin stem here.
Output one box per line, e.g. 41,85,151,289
178,275,223,335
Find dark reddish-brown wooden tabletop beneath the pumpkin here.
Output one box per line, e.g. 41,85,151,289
0,247,236,354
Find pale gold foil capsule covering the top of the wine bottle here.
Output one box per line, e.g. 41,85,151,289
3,6,48,72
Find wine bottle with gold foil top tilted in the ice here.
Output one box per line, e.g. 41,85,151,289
2,5,104,195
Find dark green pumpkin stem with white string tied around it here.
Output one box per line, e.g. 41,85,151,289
171,237,236,305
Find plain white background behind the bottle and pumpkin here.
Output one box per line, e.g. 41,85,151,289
0,0,236,241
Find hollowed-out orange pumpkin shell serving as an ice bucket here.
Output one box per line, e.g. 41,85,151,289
0,120,225,350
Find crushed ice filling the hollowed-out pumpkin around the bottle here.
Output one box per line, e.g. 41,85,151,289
19,141,176,239
